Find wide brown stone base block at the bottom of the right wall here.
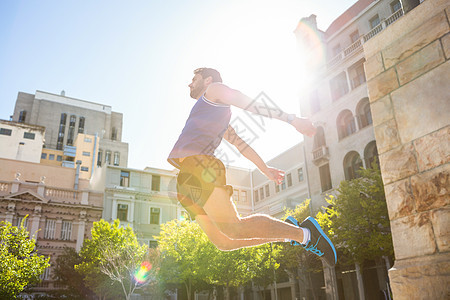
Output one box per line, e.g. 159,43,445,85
389,253,450,300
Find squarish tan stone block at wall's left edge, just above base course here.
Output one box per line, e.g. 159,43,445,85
391,212,437,259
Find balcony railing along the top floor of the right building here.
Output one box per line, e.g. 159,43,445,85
327,8,403,68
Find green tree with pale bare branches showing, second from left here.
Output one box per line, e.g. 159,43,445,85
75,220,147,300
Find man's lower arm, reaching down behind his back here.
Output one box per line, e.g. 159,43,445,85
223,126,284,184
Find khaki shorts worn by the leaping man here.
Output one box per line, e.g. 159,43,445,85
177,155,233,220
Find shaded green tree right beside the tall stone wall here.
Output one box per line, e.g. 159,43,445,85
317,163,393,264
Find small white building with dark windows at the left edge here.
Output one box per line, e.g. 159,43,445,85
0,120,45,162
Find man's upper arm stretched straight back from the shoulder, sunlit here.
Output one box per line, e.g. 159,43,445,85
205,82,316,137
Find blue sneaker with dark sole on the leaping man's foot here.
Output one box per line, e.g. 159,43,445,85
286,217,337,266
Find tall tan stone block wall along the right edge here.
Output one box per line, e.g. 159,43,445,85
364,0,450,299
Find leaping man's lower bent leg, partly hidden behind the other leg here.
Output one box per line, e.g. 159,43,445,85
195,215,284,251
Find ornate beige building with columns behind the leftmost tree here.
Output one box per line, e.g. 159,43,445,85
0,158,103,294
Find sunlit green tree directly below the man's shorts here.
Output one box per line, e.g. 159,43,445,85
156,220,215,299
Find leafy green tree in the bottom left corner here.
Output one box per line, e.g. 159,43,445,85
0,221,50,299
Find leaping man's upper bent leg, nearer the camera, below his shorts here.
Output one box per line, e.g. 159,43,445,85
203,187,303,241
